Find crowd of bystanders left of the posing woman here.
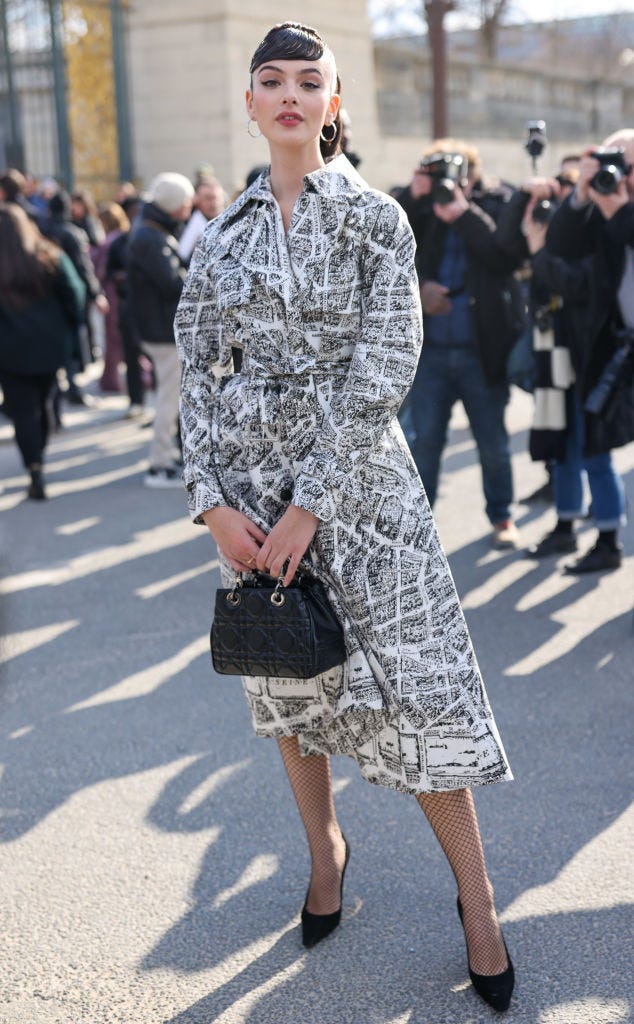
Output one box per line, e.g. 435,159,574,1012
0,166,226,493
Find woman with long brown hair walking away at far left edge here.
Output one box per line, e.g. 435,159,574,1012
0,203,85,501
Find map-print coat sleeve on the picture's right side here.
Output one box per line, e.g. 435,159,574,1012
293,204,422,521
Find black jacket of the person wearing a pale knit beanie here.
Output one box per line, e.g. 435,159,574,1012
127,203,186,344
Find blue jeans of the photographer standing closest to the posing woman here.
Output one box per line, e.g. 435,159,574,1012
400,345,513,523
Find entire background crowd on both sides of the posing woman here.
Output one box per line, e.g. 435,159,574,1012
0,121,634,572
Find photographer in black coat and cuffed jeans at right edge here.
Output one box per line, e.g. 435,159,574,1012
524,130,634,572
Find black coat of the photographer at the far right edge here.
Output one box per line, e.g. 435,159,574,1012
539,199,634,455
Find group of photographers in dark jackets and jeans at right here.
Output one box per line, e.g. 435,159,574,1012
393,129,634,573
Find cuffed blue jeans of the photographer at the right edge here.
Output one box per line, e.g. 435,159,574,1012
553,392,625,530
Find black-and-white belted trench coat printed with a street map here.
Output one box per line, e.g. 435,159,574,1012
176,157,512,793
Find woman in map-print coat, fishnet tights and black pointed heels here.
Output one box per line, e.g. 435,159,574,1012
176,23,513,1010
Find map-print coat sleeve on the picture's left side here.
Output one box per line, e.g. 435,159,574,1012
174,229,233,523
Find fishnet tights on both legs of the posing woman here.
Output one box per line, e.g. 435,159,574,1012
278,736,508,974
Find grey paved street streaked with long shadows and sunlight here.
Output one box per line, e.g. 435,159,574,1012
0,392,634,1024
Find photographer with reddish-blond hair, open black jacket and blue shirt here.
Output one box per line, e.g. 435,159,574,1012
395,139,523,548
